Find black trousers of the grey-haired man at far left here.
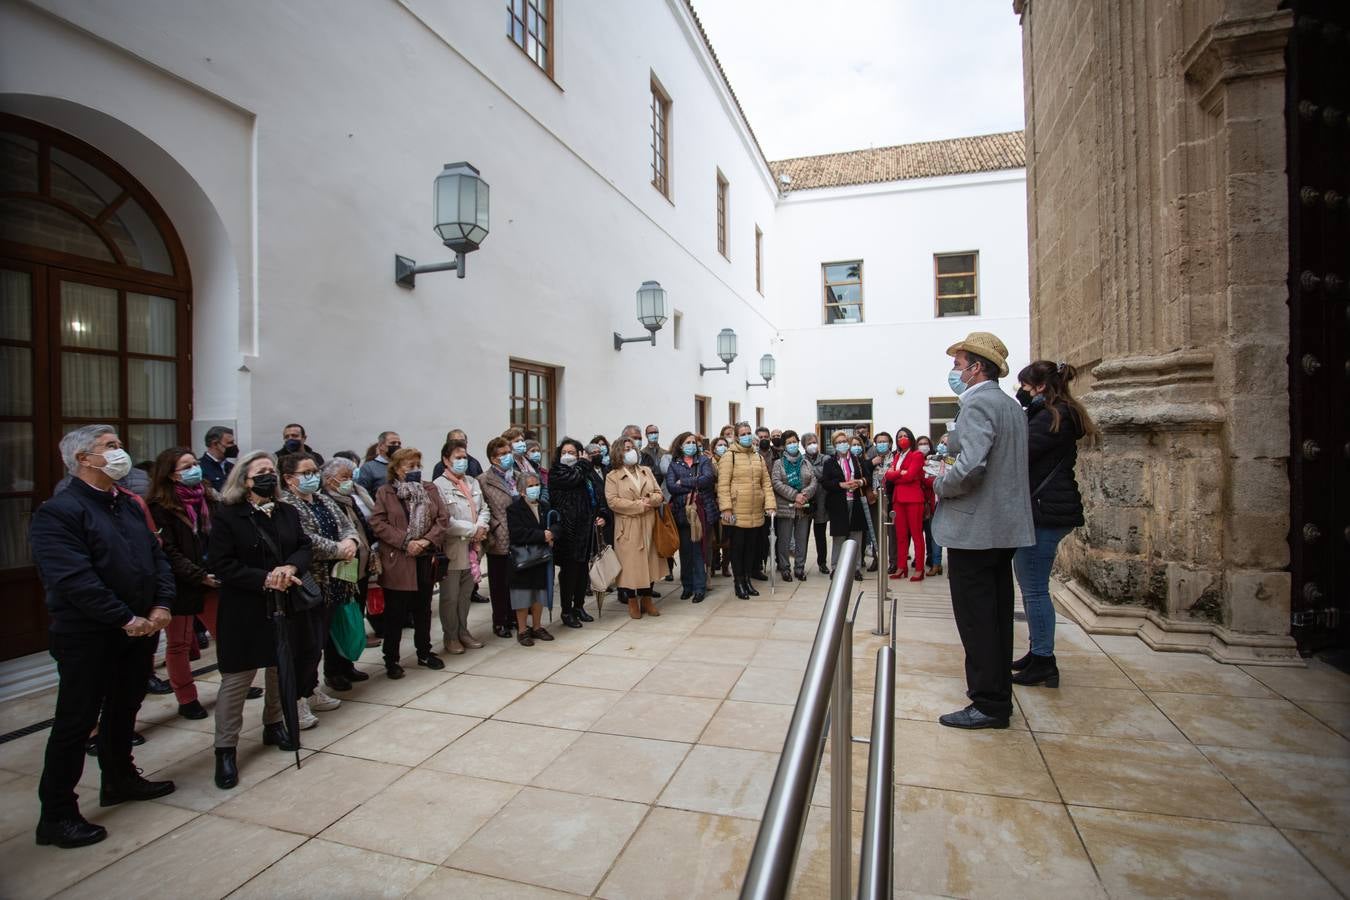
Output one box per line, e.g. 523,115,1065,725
38,629,158,822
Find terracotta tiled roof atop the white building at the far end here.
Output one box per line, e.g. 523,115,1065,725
770,131,1026,190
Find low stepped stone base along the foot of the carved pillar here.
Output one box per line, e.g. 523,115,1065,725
1050,578,1307,667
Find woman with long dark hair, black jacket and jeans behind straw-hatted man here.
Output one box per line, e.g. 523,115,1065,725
1013,359,1096,688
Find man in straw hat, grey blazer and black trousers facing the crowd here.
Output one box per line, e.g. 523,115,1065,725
933,332,1035,729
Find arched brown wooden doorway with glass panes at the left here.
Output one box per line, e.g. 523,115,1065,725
0,113,192,660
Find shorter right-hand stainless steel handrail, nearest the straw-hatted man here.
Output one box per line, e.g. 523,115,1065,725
857,646,895,900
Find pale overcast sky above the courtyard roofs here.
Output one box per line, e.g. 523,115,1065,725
693,0,1022,159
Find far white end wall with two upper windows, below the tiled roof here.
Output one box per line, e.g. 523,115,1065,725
771,169,1030,434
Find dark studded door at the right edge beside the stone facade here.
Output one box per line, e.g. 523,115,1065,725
1287,0,1350,654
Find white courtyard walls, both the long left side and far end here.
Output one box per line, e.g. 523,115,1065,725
0,0,1027,464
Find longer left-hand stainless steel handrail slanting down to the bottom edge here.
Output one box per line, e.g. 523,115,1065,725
741,540,859,900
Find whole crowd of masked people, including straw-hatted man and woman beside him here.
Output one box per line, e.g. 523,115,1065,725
31,333,1092,847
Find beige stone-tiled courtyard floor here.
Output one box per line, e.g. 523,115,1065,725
0,576,1350,900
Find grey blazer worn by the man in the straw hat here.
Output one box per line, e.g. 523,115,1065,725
933,382,1035,551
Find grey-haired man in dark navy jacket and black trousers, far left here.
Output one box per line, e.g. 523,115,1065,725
28,425,174,847
